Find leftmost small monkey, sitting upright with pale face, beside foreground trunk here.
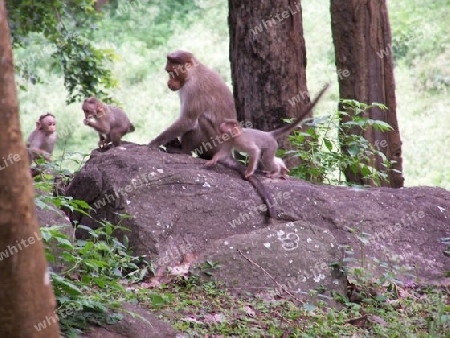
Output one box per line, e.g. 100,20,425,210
27,113,57,163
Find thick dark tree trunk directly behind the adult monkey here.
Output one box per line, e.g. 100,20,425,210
228,0,310,166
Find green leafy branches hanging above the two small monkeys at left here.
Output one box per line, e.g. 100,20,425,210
7,0,116,103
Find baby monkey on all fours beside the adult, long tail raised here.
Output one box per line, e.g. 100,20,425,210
205,84,329,179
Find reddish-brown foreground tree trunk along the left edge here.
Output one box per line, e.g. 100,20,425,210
0,0,59,338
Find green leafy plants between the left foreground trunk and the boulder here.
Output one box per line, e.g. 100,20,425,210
35,164,149,337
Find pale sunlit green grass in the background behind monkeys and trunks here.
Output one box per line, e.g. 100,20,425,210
14,0,450,189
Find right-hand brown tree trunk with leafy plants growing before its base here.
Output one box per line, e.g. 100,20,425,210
331,0,404,188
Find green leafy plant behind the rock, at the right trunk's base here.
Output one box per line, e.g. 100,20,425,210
281,100,392,185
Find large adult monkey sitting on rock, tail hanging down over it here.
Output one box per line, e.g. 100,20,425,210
149,50,277,218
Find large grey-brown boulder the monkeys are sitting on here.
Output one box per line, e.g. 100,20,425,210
67,144,450,296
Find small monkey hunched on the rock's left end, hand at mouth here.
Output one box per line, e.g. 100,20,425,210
81,97,135,148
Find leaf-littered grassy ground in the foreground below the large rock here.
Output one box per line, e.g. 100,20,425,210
138,276,450,338
